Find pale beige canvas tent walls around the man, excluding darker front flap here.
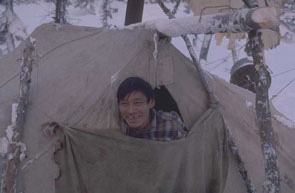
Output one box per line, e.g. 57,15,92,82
0,24,295,193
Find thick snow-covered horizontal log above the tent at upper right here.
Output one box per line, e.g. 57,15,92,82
125,7,279,37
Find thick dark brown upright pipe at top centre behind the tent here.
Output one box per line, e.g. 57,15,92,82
125,0,144,26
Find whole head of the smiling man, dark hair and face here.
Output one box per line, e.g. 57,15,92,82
117,77,155,129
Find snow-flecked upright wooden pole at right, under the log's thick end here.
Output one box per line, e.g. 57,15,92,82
243,0,280,193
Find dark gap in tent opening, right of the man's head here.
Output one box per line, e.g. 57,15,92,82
154,86,182,119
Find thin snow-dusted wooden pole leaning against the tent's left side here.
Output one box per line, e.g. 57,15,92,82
5,38,37,193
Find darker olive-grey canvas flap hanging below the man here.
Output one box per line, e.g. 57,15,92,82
55,108,228,193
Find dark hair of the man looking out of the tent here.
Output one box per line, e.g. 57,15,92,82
117,77,154,103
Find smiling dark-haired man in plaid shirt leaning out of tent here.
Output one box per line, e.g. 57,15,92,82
117,77,187,141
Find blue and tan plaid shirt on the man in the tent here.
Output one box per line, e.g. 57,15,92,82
125,109,187,141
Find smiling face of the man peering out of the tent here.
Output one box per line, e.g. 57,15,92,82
119,91,155,129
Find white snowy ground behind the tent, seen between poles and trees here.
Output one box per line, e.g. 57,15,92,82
8,1,295,121
